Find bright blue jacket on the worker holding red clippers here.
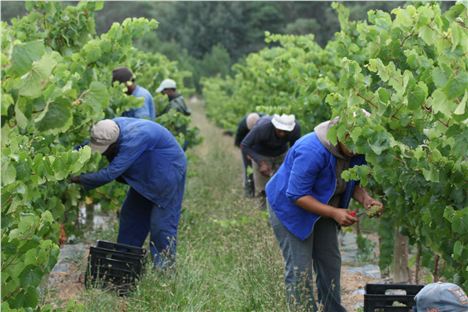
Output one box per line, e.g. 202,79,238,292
266,132,364,240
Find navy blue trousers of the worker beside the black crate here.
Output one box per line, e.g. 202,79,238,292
117,188,181,268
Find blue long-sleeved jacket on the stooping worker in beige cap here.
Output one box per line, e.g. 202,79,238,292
80,117,187,209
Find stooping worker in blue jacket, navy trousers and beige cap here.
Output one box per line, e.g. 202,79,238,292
71,117,187,268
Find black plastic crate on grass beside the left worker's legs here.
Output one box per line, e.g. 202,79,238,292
85,241,146,295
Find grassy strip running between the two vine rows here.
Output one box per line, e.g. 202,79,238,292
78,106,287,312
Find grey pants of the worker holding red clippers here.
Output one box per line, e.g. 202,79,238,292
268,205,346,312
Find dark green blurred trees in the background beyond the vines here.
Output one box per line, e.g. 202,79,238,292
1,1,454,92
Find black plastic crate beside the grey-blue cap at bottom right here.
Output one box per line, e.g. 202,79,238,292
364,284,424,312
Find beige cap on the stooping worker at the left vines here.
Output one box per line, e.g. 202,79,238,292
89,119,120,154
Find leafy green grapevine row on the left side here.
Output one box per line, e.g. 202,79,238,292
1,2,197,311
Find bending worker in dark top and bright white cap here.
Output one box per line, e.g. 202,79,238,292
241,114,301,208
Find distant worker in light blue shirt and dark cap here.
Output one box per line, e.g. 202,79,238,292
112,67,156,120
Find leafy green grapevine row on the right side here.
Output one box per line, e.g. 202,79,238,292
204,3,468,288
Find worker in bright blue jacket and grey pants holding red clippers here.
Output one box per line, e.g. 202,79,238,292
266,115,383,312
